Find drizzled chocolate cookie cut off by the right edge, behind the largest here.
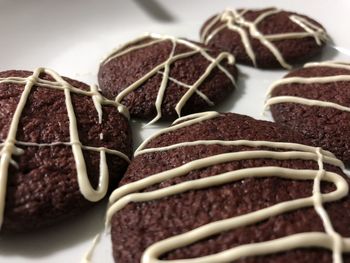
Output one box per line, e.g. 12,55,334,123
266,61,350,165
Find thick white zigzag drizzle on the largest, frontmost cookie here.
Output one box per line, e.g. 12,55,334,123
106,112,350,263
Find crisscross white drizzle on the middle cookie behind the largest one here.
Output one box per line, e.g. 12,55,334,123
101,33,235,124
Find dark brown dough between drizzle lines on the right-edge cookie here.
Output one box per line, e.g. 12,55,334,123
271,63,350,165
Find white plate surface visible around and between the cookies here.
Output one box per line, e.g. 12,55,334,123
0,0,350,263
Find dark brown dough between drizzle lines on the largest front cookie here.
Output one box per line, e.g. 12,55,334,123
112,113,350,263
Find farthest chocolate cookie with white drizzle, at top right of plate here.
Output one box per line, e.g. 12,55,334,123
200,8,328,69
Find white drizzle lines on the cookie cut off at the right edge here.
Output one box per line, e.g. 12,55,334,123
264,61,350,112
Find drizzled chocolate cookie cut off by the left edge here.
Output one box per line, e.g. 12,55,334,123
0,68,131,232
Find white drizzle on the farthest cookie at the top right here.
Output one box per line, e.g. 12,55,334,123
201,8,328,69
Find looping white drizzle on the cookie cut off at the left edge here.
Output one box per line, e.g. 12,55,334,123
0,68,130,227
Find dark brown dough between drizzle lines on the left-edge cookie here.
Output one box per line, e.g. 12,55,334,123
0,70,131,232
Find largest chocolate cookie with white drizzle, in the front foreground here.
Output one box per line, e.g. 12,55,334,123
107,112,350,263
